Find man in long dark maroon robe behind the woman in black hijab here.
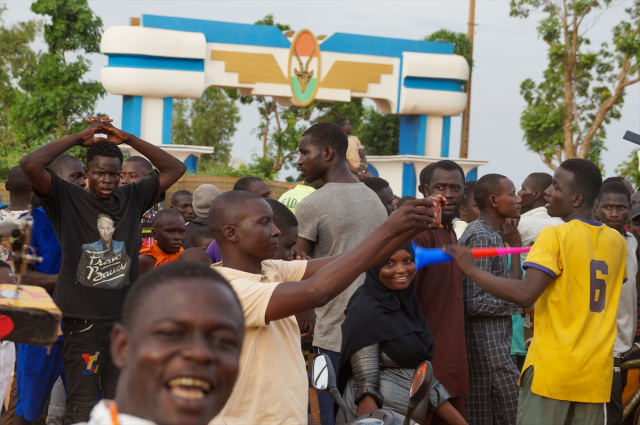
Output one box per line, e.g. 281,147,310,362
413,160,469,425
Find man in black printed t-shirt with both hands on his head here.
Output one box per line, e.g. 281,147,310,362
20,117,186,424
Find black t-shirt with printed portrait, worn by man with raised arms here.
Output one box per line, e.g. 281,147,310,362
36,170,164,321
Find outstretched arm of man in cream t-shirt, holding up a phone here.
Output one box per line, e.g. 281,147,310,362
265,199,435,322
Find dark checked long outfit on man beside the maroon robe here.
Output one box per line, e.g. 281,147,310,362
458,218,522,425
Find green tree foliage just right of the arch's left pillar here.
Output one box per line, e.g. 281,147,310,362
171,87,240,170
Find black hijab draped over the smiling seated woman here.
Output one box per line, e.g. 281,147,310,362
338,242,435,390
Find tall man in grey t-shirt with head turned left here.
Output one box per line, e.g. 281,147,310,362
296,122,387,425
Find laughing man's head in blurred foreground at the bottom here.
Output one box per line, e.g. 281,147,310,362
78,261,244,425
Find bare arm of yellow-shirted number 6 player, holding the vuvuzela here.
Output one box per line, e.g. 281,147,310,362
444,245,553,307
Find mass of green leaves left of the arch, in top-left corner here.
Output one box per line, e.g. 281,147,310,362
0,0,105,177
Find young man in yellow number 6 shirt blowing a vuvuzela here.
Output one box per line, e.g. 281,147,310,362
446,158,627,425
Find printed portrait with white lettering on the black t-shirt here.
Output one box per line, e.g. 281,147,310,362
77,214,131,289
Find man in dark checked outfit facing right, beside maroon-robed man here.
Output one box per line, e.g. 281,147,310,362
458,174,522,425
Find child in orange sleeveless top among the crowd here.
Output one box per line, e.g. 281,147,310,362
139,208,185,274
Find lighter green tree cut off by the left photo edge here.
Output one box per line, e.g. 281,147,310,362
0,6,40,180
